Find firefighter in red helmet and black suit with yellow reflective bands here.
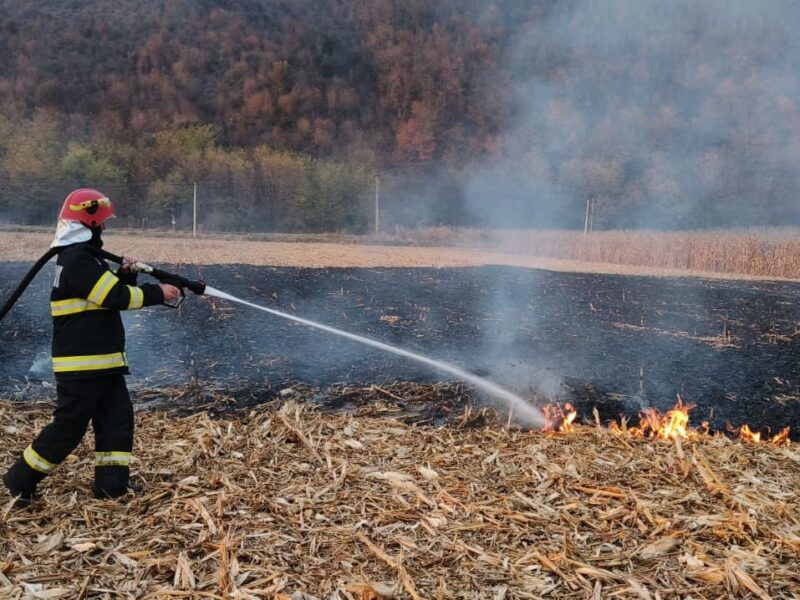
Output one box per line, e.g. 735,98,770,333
3,188,180,508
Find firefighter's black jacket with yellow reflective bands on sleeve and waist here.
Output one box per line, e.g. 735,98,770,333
50,244,164,381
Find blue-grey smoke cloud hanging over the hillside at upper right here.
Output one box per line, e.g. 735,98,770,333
464,0,800,229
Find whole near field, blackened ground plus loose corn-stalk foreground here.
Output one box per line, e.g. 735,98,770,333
0,229,800,600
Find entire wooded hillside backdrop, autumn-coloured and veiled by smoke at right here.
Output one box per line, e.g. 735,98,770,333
0,0,800,230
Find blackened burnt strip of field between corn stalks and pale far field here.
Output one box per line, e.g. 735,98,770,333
0,263,800,431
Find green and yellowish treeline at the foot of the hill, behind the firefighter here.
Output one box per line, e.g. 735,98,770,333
0,110,374,233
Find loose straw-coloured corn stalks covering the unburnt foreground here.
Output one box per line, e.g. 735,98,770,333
0,402,800,600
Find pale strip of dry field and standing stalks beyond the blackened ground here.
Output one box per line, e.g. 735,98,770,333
0,228,800,280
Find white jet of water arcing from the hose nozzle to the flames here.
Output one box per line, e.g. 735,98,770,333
205,285,545,427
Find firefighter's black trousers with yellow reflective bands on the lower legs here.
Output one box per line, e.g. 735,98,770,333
4,375,133,498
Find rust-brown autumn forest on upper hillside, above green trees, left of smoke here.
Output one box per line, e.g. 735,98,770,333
0,0,532,165
